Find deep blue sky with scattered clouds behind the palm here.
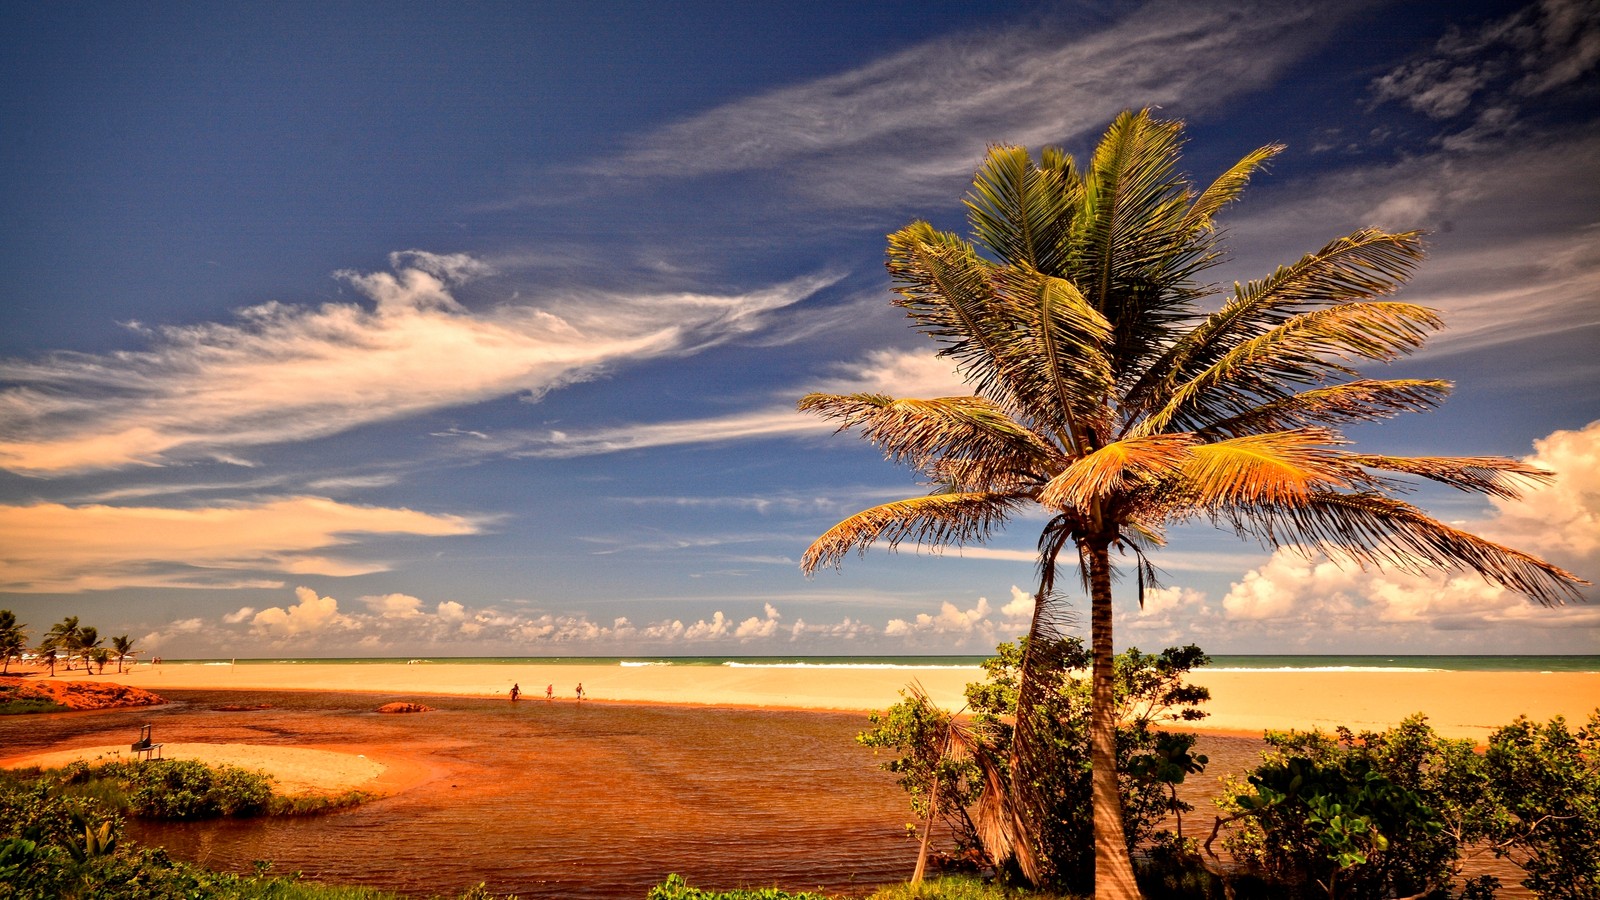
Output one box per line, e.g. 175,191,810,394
0,0,1600,658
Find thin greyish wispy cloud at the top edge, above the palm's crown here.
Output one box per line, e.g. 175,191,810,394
576,2,1357,207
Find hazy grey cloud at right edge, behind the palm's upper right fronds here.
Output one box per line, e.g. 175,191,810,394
1227,128,1600,360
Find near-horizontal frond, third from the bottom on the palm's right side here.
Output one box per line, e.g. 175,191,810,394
1202,378,1450,437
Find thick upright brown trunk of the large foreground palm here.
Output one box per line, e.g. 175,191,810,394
1085,541,1139,900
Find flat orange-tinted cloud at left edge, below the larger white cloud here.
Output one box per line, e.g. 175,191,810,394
0,496,485,593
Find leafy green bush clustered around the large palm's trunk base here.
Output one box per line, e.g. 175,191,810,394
856,637,1210,892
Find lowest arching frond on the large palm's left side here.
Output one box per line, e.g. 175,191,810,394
800,492,1027,575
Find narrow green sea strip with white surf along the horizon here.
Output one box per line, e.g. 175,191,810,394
163,653,1600,673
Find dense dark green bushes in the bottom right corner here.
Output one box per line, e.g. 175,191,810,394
1205,711,1600,900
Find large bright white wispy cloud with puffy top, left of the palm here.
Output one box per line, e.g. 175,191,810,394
0,251,832,476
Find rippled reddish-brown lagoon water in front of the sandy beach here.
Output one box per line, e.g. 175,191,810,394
0,692,1520,898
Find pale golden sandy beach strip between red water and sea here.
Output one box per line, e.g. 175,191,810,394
25,661,1600,743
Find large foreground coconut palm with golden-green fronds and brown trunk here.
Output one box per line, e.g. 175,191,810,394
800,110,1584,898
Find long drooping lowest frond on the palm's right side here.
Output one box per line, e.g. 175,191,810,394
1230,492,1589,605
